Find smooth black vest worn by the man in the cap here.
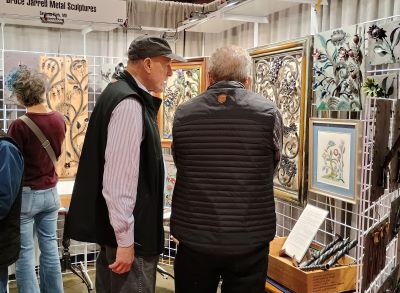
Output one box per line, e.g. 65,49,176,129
64,71,164,255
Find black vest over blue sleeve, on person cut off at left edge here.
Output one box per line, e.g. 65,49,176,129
0,131,23,267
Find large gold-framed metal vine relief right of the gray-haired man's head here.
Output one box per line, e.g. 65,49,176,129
249,38,311,203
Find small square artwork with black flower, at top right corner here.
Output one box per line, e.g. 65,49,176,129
365,21,400,65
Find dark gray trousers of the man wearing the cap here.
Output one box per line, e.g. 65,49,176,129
96,246,158,293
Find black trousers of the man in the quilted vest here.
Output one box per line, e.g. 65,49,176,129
174,244,269,293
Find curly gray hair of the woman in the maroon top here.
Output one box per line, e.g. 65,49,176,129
11,65,47,107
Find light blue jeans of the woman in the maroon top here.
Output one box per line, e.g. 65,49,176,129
16,187,63,293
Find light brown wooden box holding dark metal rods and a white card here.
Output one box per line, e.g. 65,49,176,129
268,237,357,293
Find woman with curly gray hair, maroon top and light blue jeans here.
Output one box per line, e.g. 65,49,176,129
6,66,65,293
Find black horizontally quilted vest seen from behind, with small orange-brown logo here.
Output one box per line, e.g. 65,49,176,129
171,82,278,255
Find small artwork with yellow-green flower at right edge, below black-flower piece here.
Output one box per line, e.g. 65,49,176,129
362,74,398,100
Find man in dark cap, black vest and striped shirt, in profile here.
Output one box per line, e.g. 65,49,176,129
64,37,185,293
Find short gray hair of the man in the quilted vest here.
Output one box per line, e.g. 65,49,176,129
208,46,251,82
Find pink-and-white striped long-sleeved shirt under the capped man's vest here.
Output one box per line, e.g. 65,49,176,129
103,79,147,247
